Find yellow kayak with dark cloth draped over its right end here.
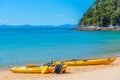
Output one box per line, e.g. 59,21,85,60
10,65,67,74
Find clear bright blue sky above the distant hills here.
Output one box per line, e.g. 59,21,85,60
0,0,95,25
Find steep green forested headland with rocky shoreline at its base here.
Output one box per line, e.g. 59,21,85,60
72,0,120,31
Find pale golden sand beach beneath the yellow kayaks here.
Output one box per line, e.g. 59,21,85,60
0,57,120,80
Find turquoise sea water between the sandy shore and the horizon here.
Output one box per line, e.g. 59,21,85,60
0,29,120,67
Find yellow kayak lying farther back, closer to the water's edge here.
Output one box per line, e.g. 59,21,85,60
54,57,116,66
